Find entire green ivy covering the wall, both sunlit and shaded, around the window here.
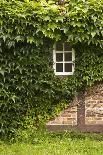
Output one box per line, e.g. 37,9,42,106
0,0,103,137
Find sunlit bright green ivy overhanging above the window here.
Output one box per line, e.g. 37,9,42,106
0,0,103,46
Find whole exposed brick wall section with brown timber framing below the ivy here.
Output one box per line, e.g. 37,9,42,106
47,84,103,131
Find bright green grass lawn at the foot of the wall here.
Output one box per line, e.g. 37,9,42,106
0,132,103,155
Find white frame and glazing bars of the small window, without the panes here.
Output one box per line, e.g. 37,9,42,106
53,43,75,75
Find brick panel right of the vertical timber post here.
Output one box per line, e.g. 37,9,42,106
85,85,103,125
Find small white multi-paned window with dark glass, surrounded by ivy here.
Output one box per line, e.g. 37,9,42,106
53,42,75,75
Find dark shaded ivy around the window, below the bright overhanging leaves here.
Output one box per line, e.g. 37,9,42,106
0,42,103,138
